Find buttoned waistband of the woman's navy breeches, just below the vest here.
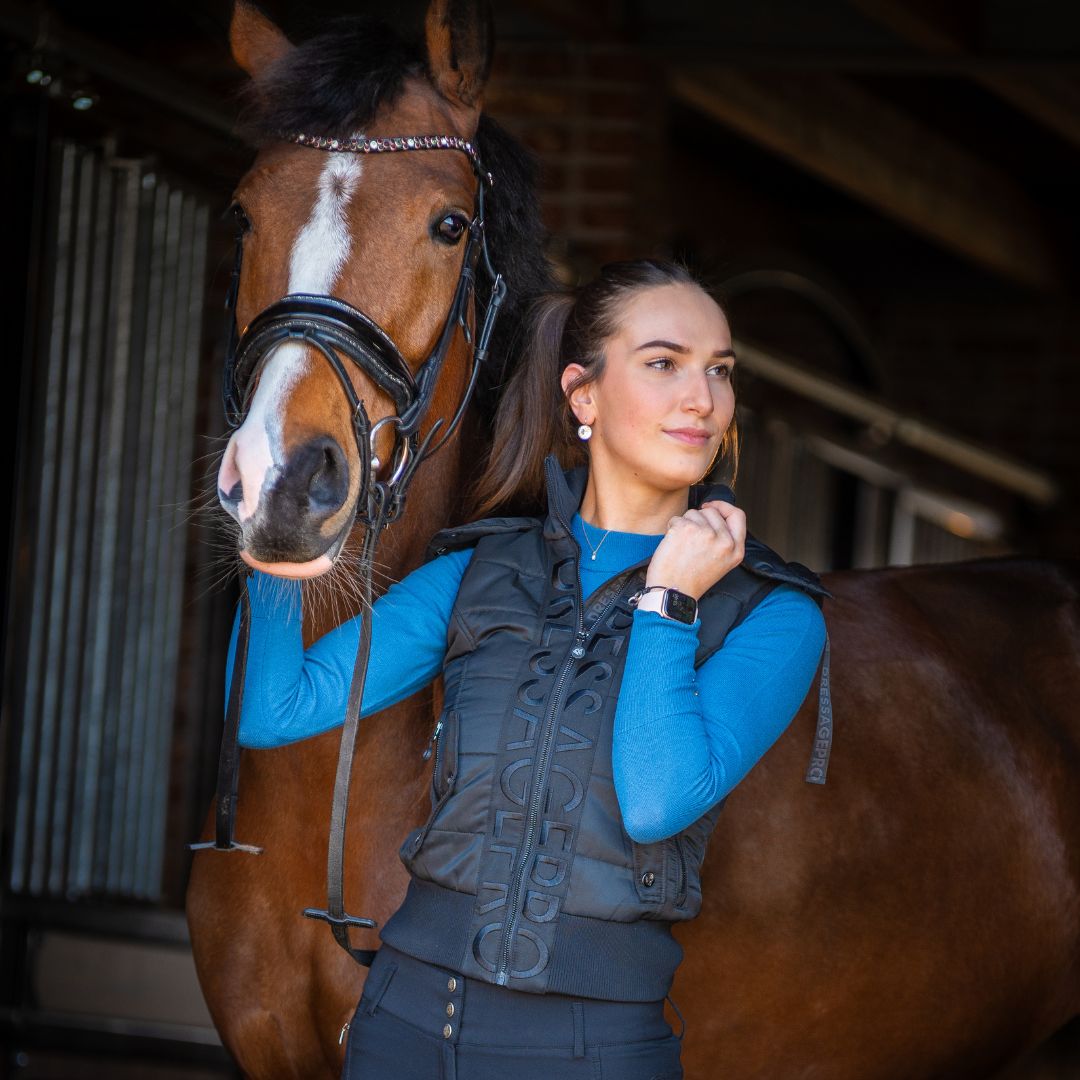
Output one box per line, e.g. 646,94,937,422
371,945,672,1053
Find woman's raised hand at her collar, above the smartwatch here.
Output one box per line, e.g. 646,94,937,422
645,500,746,599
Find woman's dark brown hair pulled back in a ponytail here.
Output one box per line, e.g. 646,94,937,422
475,259,739,516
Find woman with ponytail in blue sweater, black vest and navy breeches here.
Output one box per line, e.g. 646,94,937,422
234,260,824,1080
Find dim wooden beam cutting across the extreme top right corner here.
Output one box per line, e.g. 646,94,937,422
848,0,1080,146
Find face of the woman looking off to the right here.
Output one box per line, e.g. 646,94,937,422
564,285,735,491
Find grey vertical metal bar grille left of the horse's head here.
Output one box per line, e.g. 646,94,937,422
10,141,208,899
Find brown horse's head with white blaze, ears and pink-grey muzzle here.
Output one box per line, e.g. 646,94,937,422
218,0,490,578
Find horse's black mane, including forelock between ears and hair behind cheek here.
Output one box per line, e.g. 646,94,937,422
240,15,554,422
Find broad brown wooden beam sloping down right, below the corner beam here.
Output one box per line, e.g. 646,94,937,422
671,67,1062,291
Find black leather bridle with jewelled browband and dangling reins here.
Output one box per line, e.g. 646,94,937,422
190,132,507,964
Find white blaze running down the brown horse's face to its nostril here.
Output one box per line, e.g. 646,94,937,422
218,153,363,572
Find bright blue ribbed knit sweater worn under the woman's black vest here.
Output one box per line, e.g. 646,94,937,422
229,515,825,843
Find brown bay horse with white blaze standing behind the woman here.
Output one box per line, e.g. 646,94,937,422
187,0,1080,1080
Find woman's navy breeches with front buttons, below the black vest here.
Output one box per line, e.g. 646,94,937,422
342,945,683,1080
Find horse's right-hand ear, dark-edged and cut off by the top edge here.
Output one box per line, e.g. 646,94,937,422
426,0,495,109
